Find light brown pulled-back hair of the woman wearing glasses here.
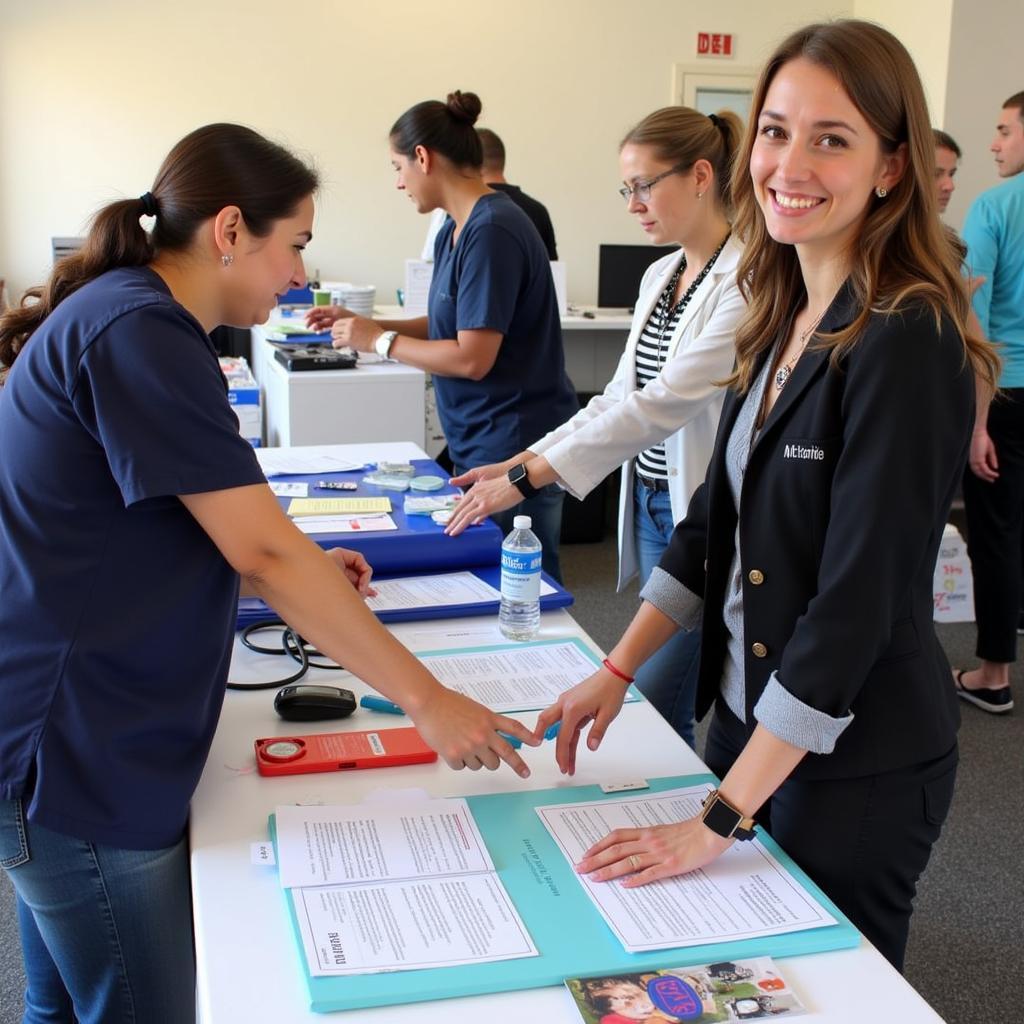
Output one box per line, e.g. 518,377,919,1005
618,106,743,216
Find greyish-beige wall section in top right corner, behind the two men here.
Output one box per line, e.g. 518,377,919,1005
942,0,1024,228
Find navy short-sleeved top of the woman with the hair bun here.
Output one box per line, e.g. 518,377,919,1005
427,193,580,472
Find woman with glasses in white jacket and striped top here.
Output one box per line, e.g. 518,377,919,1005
447,106,744,746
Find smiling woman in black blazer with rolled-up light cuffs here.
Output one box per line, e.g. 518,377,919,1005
538,20,997,967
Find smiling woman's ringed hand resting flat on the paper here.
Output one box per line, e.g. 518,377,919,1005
575,817,735,889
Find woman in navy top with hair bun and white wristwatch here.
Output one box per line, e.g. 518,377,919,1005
307,92,579,581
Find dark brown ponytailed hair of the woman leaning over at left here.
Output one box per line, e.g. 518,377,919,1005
0,124,317,381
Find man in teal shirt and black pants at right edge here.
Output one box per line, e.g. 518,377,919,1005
953,92,1024,715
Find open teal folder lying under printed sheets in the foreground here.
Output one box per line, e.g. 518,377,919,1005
270,775,860,1013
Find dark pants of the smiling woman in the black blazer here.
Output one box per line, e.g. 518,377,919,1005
705,700,957,971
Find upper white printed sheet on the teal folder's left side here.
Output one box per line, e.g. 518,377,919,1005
274,800,495,889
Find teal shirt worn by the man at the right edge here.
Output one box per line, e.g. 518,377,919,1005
963,173,1024,388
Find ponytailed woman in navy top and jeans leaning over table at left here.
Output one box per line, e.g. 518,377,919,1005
0,124,536,1024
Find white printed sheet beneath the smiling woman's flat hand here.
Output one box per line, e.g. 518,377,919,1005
537,785,836,952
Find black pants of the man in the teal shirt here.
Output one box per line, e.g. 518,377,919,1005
964,388,1024,663
